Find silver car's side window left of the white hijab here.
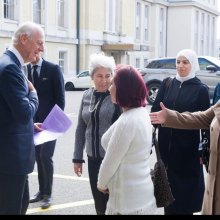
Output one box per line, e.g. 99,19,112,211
146,59,176,69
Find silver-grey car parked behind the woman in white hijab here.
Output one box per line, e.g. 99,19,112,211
140,56,220,104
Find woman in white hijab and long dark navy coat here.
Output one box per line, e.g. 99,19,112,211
151,49,210,215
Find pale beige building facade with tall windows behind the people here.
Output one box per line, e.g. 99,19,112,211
0,0,219,76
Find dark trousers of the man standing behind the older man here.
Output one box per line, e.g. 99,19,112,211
35,141,56,196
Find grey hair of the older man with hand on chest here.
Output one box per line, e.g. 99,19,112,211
12,21,44,45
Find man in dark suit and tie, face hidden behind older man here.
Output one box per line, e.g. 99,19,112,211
27,56,65,209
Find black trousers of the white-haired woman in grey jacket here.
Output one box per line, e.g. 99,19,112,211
88,157,108,215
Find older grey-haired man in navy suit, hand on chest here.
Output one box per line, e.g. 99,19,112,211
0,22,44,215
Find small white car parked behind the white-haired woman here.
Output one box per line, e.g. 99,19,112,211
64,70,93,91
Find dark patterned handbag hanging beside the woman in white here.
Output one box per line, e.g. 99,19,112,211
150,128,175,208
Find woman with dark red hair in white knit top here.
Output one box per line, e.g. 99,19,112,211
98,65,156,215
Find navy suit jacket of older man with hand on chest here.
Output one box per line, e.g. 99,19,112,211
0,51,38,175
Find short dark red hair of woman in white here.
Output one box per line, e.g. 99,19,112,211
113,64,147,108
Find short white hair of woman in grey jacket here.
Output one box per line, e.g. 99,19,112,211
89,53,116,76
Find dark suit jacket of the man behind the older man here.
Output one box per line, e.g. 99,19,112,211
27,60,65,122
